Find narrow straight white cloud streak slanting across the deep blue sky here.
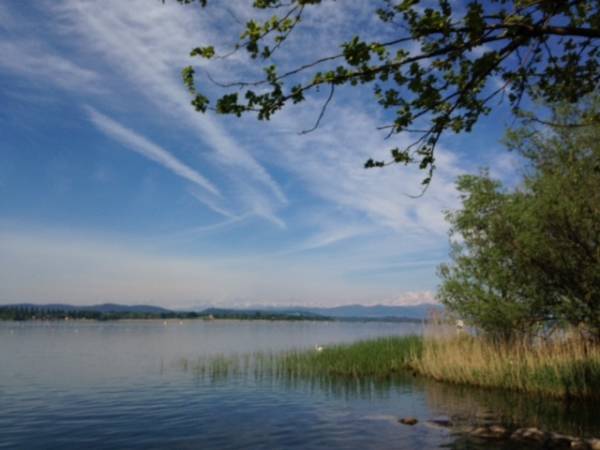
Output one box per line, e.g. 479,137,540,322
86,107,220,195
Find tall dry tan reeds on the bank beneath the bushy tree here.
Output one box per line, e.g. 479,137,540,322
411,335,600,398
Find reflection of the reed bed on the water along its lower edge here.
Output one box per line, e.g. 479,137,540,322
177,353,600,449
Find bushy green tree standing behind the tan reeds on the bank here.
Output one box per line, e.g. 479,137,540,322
439,98,600,340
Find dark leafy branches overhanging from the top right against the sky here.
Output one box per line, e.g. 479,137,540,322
178,0,600,185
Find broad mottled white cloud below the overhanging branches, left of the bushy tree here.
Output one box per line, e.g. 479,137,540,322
267,106,460,239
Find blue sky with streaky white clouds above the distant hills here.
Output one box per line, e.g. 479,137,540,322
0,0,517,308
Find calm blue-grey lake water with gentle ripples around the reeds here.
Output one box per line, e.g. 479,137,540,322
0,321,600,449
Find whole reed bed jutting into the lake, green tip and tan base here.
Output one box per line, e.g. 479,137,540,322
186,335,600,399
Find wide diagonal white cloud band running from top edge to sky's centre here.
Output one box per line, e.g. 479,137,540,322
54,0,287,214
